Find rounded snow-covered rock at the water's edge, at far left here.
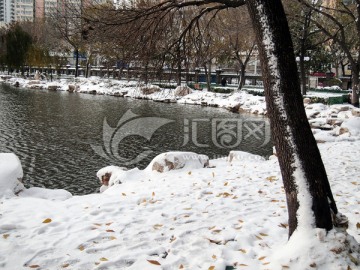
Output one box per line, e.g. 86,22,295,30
0,153,24,197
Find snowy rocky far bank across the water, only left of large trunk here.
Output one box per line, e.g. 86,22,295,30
5,77,266,115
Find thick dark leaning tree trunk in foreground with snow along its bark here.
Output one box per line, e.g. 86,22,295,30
246,0,337,237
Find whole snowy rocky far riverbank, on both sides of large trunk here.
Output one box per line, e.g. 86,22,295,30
1,76,360,142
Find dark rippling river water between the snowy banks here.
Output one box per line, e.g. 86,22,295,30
0,84,272,195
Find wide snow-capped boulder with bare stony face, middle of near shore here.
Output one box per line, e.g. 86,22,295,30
147,152,209,173
